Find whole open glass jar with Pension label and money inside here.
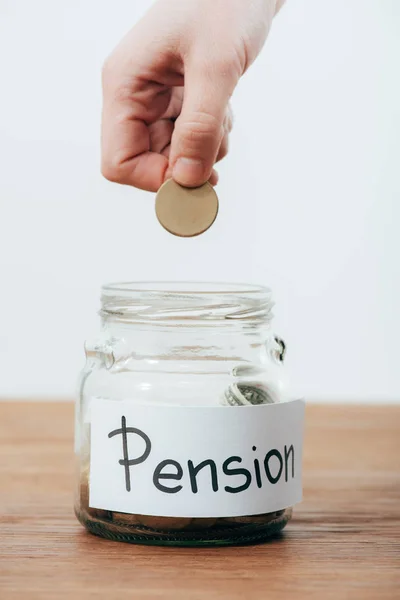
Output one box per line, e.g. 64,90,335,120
75,283,303,545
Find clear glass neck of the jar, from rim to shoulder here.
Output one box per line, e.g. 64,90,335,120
96,283,273,361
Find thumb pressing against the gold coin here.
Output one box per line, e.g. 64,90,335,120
170,64,239,187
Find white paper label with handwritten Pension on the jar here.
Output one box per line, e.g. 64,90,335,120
89,399,304,517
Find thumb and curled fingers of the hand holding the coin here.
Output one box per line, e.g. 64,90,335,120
102,43,239,191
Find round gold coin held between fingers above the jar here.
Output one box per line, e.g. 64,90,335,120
156,179,218,237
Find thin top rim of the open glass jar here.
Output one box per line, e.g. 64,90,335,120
101,281,271,297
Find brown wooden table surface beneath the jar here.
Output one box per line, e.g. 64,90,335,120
0,402,400,600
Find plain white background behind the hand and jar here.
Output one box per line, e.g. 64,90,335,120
0,0,400,401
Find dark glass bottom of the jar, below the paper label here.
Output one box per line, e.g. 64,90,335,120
75,507,292,546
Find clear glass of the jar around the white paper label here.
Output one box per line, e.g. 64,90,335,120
75,283,291,545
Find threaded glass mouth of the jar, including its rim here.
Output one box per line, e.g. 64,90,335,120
100,281,274,325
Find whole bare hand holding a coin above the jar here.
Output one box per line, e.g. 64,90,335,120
102,0,283,191
